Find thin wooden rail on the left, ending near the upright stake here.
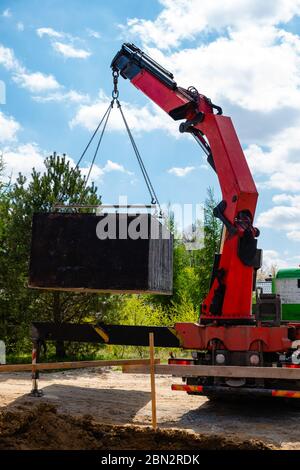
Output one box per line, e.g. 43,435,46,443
0,359,160,373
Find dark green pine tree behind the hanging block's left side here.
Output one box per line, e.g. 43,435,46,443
0,154,100,357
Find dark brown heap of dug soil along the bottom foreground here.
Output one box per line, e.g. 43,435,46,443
0,402,272,451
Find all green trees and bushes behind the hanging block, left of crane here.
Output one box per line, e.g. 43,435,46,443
0,149,221,357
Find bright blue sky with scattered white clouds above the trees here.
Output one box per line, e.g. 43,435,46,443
0,0,300,269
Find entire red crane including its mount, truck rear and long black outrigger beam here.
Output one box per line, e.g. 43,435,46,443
32,44,300,398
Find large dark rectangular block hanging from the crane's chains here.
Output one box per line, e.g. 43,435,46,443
29,213,173,294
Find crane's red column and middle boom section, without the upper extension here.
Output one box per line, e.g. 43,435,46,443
195,114,258,319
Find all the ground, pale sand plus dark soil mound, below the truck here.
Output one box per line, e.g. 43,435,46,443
0,368,300,450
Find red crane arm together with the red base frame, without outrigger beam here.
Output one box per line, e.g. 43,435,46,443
112,44,300,352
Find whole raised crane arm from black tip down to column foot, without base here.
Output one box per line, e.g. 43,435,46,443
112,44,261,323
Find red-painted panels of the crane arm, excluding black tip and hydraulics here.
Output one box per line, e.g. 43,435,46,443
131,70,258,320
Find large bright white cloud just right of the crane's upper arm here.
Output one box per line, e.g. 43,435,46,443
142,24,300,113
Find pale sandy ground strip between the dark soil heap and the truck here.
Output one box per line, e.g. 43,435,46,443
0,368,300,450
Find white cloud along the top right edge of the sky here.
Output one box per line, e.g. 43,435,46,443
122,0,300,49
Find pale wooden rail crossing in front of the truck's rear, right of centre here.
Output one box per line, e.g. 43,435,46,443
123,364,300,380
